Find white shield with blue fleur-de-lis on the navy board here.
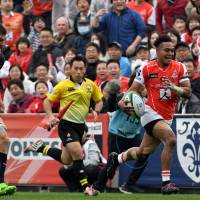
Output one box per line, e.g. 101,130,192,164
176,118,200,183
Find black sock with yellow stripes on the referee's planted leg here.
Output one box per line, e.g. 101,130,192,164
73,160,89,191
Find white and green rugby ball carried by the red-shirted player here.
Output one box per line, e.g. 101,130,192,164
123,92,145,117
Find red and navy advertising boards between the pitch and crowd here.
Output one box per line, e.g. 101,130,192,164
2,114,200,187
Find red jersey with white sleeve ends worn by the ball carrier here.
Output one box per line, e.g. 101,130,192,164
135,60,189,120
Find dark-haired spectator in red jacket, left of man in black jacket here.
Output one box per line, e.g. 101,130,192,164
9,37,32,74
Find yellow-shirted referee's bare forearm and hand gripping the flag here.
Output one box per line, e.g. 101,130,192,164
43,98,59,127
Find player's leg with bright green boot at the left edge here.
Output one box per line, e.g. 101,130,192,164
0,120,17,196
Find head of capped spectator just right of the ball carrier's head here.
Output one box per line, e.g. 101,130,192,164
175,42,192,62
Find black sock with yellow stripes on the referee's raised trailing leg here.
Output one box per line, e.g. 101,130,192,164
40,146,62,163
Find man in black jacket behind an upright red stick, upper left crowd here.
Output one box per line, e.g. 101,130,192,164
29,28,63,79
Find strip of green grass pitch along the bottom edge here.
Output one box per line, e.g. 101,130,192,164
3,192,200,200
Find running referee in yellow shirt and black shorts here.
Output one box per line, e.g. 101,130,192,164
26,56,103,196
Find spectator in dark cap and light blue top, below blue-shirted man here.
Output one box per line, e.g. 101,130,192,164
107,42,131,77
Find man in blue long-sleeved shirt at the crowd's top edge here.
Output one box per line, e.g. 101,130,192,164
92,0,146,56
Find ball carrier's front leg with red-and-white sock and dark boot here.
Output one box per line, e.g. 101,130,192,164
153,120,179,194
